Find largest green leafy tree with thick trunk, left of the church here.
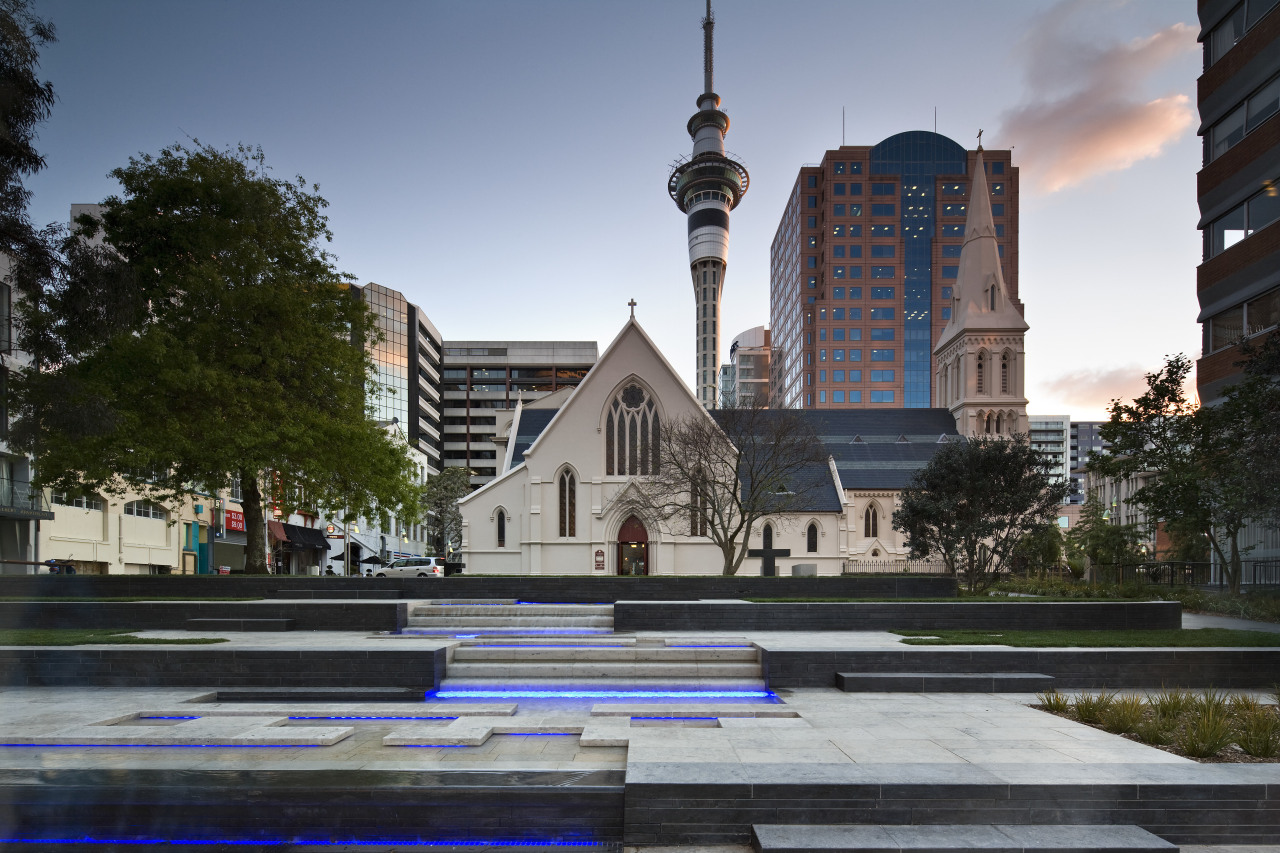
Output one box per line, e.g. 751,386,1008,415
13,143,420,573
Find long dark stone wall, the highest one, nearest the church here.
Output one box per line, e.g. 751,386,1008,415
0,575,956,596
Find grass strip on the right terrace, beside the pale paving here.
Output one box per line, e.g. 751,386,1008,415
892,628,1280,648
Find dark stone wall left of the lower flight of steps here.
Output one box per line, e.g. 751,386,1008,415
0,646,445,692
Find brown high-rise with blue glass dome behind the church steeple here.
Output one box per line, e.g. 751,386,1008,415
769,131,1021,409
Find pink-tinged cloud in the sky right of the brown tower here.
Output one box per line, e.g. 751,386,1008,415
996,0,1197,192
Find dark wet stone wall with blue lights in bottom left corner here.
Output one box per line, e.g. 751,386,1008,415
0,751,622,835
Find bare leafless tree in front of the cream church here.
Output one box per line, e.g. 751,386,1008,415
637,407,835,575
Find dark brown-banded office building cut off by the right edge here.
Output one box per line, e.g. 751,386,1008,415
1196,0,1280,403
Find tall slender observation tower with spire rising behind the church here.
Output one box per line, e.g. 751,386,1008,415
667,0,750,409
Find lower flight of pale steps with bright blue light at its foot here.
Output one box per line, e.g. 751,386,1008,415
440,638,768,698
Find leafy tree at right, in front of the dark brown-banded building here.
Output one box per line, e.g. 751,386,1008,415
1089,355,1274,592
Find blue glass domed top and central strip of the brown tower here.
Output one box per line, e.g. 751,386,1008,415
869,131,968,409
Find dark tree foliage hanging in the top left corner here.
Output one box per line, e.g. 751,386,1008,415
0,0,55,260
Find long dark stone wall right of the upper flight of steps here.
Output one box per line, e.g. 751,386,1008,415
613,601,1183,631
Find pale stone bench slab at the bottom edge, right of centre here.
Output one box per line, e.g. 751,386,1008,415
751,824,1179,853
